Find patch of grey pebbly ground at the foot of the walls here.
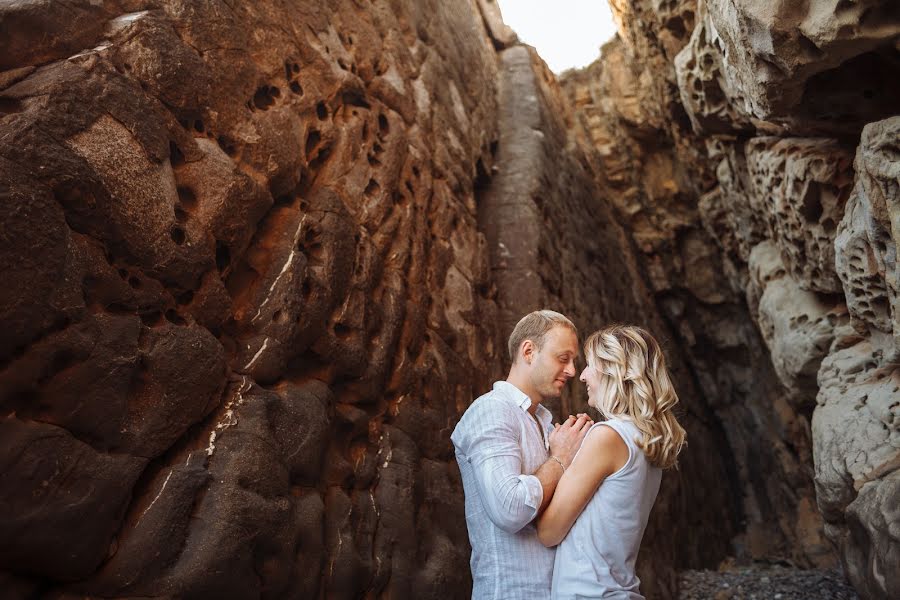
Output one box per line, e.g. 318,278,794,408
678,563,859,600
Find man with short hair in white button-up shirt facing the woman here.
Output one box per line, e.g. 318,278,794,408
451,310,591,600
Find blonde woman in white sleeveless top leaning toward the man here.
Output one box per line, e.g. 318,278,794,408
538,325,685,600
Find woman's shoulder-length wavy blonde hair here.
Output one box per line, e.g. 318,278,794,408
584,325,685,469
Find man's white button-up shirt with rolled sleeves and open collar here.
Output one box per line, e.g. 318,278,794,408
450,381,555,600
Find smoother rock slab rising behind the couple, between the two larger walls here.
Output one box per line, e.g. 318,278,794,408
476,45,738,598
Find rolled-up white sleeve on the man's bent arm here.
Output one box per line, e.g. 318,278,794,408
454,402,544,533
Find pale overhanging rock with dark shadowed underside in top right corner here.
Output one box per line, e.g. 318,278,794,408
700,0,900,134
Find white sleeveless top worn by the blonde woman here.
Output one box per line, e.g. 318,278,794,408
551,418,662,600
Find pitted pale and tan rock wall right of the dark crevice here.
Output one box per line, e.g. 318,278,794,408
563,0,900,598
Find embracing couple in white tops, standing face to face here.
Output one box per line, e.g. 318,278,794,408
451,310,685,600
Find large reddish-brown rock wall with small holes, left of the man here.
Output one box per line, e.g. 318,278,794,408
0,0,503,598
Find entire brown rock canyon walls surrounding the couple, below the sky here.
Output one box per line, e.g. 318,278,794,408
0,0,900,599
